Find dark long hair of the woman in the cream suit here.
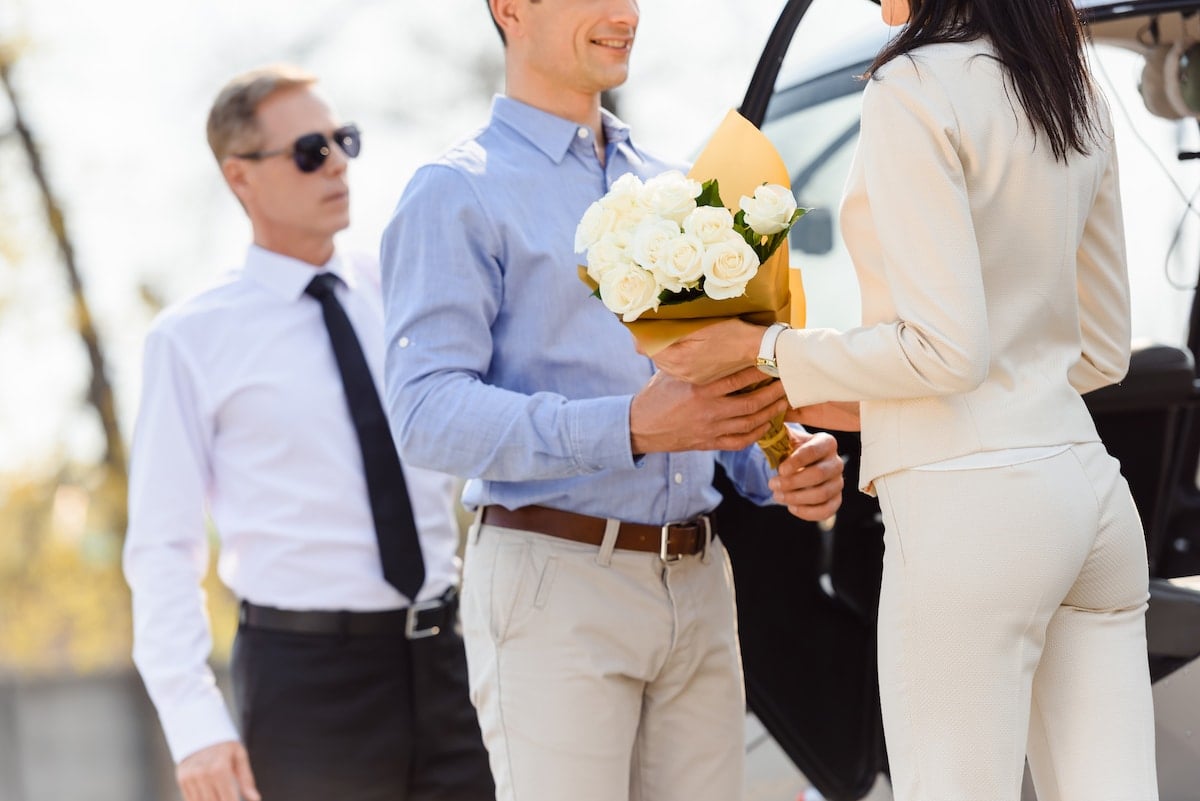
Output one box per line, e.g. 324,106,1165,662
868,0,1098,161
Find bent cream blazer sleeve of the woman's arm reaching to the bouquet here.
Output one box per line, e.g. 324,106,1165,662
776,58,990,406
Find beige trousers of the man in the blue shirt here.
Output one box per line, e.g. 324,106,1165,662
462,522,745,801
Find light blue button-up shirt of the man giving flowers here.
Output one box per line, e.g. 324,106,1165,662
382,97,770,525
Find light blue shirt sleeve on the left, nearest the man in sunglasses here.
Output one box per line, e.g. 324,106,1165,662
380,164,634,481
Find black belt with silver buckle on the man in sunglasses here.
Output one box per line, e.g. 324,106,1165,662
238,586,458,639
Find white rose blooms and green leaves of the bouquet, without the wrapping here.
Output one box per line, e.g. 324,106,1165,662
575,171,805,323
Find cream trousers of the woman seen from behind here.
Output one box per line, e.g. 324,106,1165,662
875,444,1158,801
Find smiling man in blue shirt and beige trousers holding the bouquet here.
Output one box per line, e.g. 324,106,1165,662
383,0,842,801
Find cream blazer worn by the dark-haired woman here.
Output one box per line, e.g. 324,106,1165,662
776,40,1130,492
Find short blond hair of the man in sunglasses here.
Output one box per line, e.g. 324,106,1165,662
208,64,317,164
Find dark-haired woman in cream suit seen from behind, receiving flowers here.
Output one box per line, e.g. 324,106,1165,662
655,0,1158,801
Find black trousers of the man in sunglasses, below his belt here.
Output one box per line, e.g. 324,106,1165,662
232,626,496,801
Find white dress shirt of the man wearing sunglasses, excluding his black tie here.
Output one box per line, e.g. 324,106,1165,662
125,247,458,761
